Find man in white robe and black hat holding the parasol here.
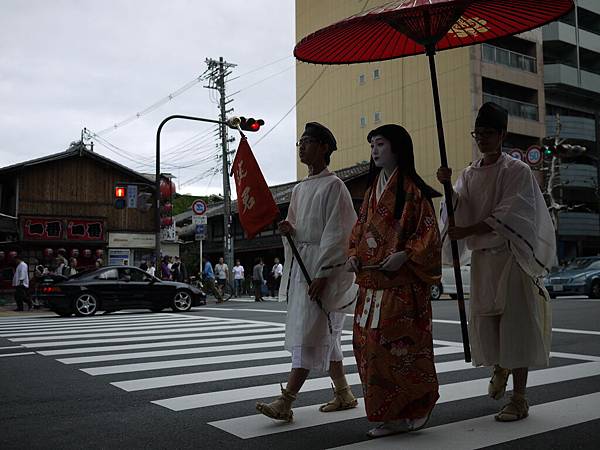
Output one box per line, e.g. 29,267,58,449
438,102,556,422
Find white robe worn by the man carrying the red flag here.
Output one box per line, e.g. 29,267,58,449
279,169,357,370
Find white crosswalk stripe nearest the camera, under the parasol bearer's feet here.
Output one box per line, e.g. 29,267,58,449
335,392,600,450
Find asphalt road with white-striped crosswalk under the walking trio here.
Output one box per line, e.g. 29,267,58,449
0,298,600,450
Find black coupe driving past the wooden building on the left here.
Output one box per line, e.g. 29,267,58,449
36,266,206,316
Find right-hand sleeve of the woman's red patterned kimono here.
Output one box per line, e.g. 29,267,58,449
404,192,441,282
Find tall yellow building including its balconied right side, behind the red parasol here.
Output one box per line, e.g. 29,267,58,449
296,0,545,192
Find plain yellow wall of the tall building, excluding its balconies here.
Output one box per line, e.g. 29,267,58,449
296,0,481,189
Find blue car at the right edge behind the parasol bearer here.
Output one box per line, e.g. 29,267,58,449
544,256,600,298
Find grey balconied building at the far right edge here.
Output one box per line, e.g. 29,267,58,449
543,0,600,260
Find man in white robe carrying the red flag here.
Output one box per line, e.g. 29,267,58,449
256,122,357,422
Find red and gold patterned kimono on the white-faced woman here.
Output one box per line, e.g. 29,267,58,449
349,173,441,422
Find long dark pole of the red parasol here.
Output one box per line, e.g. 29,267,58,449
426,44,471,362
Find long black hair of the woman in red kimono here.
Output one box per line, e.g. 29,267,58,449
367,124,442,220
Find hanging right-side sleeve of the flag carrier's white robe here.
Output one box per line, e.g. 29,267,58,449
315,179,356,278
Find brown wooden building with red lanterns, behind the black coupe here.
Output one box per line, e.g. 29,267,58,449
0,143,155,267
